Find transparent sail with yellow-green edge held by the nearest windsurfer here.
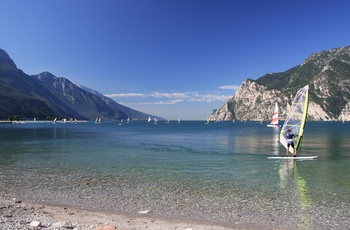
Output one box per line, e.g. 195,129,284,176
280,85,309,153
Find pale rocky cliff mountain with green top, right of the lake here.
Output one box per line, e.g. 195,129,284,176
210,46,350,121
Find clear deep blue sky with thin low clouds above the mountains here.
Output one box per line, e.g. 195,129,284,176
0,0,350,120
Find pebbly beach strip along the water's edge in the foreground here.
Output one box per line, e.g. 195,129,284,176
0,198,288,230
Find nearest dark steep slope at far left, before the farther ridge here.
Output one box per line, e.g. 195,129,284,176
0,49,82,119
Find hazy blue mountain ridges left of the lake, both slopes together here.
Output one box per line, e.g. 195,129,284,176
0,49,160,120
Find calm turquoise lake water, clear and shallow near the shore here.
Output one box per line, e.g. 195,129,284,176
0,121,350,229
